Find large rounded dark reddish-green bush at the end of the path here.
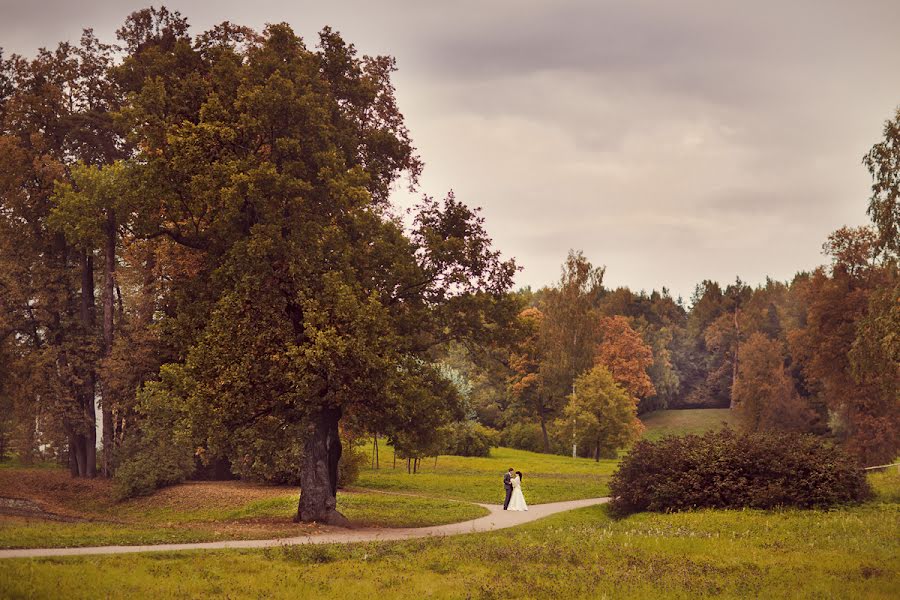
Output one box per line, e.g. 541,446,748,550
610,428,871,514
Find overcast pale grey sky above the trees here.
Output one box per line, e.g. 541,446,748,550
0,0,900,300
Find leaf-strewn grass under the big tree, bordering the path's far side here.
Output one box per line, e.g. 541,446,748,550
0,469,487,548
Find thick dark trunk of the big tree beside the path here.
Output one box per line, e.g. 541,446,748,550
295,408,349,527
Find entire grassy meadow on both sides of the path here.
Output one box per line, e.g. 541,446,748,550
0,411,900,598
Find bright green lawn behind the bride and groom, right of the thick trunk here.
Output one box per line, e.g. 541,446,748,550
356,445,618,504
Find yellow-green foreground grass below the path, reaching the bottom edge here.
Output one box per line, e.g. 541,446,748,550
0,472,900,598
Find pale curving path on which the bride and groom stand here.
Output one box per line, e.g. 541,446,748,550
0,498,609,558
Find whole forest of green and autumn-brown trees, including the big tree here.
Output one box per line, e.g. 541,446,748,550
0,8,900,523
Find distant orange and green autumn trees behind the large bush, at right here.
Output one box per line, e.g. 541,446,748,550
460,110,900,465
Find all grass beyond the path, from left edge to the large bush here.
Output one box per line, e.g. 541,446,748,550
0,447,615,548
